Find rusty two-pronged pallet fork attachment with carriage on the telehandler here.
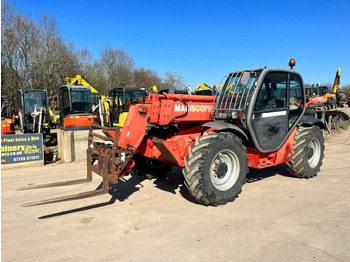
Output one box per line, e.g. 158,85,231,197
18,124,131,207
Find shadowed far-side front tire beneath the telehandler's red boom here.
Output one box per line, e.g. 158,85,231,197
133,155,172,179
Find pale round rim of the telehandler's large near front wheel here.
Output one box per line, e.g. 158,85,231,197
210,150,240,191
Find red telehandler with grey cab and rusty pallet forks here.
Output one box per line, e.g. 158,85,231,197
24,59,325,206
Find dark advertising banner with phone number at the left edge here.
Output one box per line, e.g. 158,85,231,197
1,134,44,165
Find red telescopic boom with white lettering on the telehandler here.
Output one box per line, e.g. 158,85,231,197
118,94,214,152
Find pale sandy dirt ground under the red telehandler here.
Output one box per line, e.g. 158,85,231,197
1,117,350,262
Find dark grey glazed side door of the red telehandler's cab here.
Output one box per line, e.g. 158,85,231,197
251,72,304,153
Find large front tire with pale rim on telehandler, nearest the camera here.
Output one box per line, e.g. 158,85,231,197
183,132,248,206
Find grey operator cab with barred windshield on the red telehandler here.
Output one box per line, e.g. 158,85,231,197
214,68,305,153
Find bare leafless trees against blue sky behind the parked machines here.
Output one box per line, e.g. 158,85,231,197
1,1,185,105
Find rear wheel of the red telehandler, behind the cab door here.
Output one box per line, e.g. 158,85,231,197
287,126,325,178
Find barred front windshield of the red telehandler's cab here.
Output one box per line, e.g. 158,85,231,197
215,71,257,118
